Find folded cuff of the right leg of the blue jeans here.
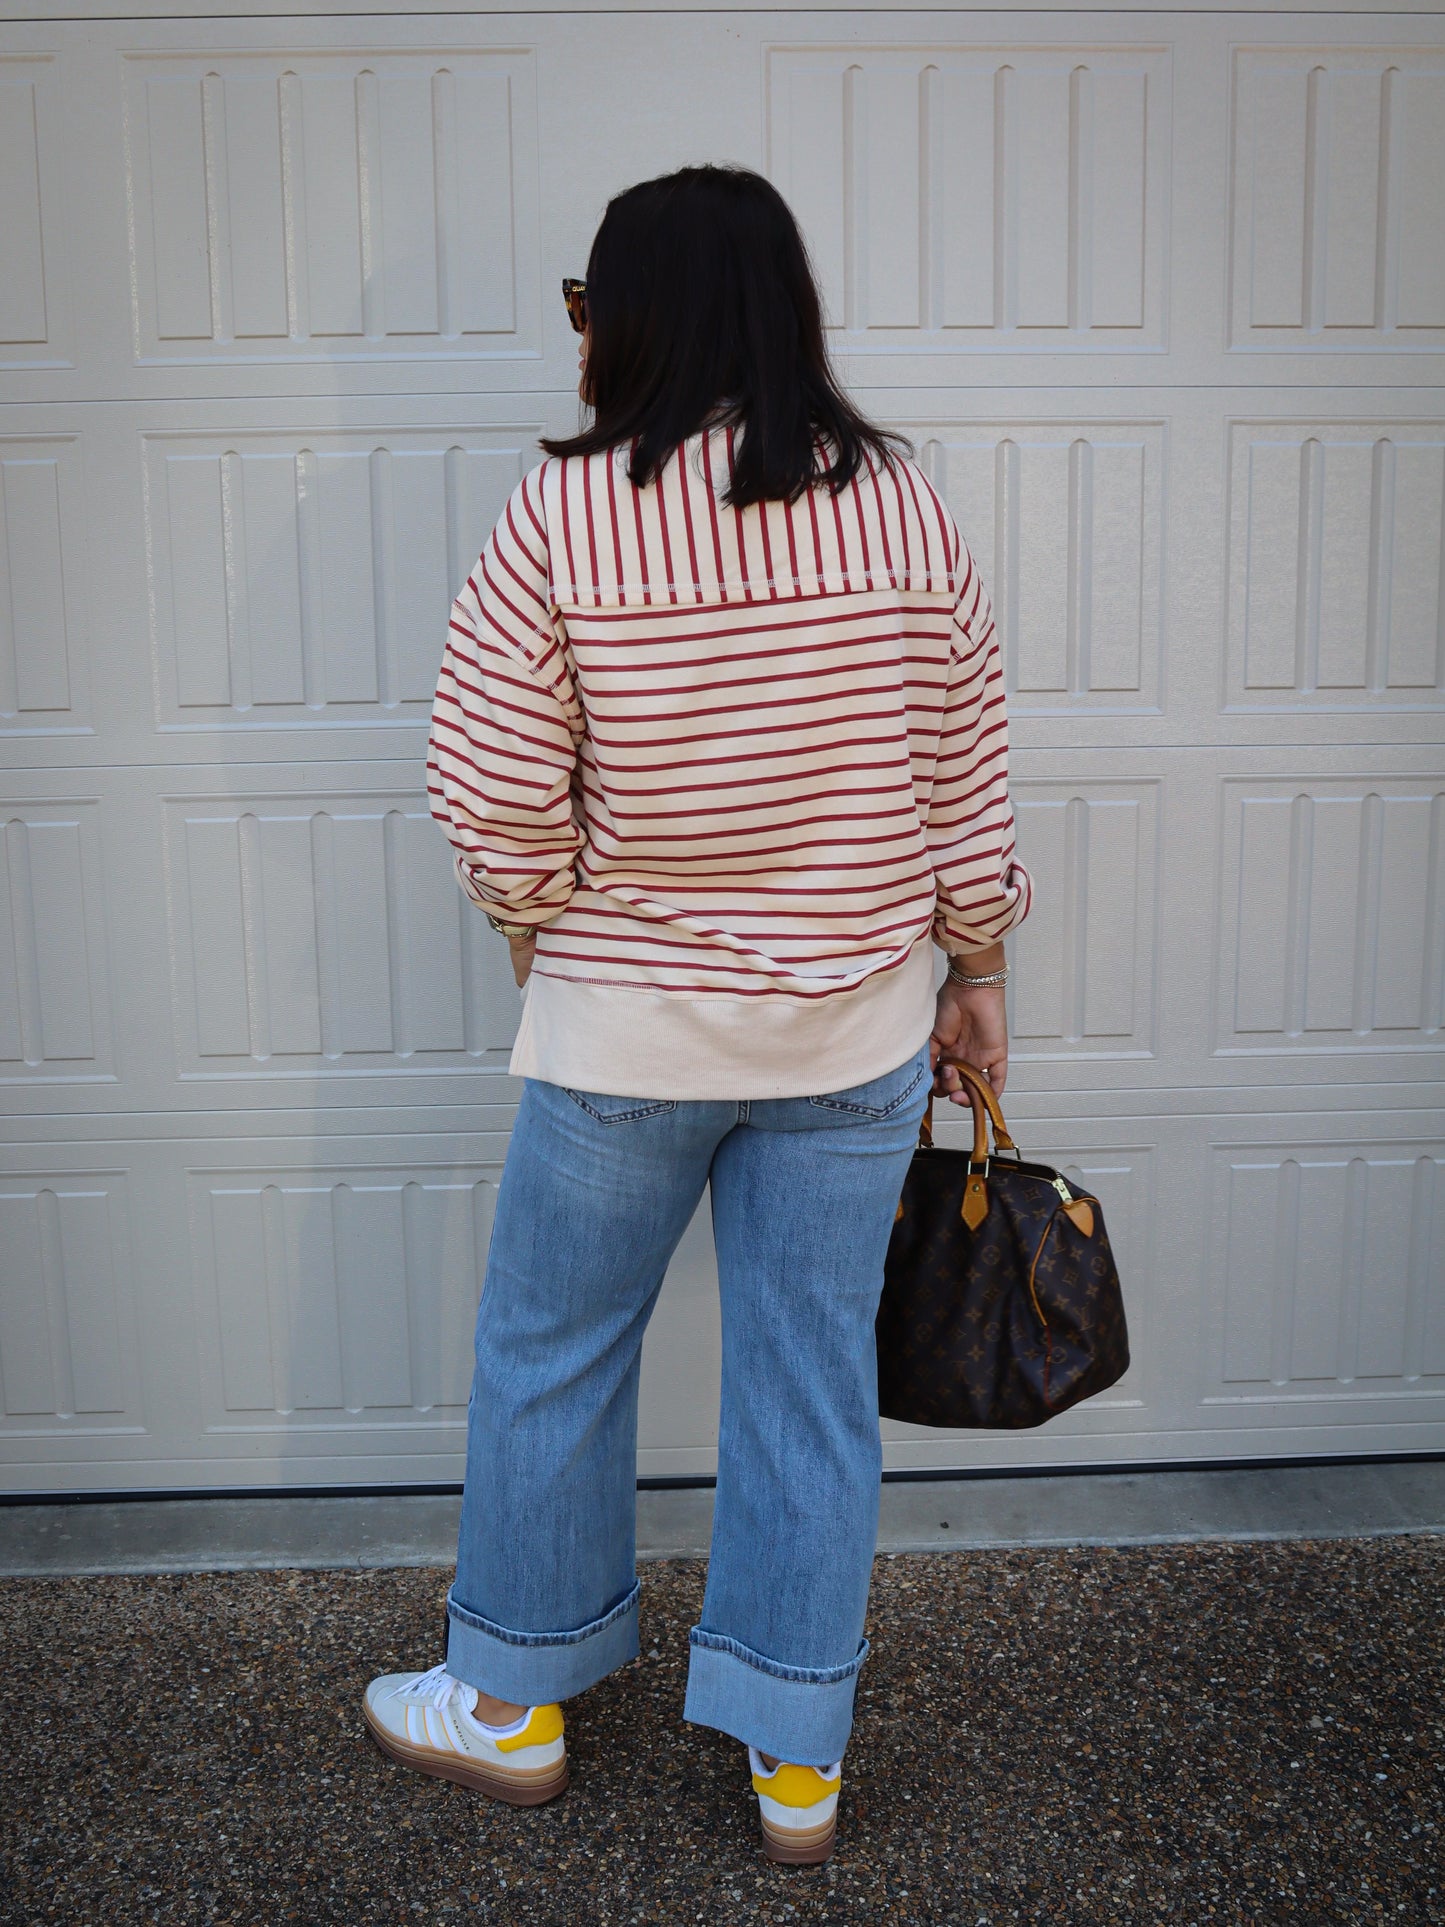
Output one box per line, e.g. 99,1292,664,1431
682,1626,869,1767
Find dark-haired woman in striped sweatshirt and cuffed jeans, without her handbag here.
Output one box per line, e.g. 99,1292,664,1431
366,168,1031,1861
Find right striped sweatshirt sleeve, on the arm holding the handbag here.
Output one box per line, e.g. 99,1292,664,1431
927,536,1033,956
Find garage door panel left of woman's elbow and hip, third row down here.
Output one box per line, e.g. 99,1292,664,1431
166,788,518,1081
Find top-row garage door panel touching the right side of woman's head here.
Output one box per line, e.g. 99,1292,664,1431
767,35,1169,351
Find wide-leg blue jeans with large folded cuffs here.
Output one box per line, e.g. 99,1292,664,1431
447,1044,931,1765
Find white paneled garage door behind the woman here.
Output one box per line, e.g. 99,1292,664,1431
0,0,1445,1490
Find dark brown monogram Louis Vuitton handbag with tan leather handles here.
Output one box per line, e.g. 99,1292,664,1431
877,1058,1129,1428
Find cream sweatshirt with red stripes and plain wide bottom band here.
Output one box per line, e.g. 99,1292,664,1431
426,426,1033,1098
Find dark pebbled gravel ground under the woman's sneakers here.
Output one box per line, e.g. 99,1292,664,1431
0,1536,1445,1927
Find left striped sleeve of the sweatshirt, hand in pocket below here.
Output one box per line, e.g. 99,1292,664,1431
426,462,584,925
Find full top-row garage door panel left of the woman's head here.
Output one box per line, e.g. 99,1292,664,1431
121,46,539,364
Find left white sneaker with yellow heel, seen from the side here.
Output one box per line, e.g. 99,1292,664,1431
362,1665,566,1806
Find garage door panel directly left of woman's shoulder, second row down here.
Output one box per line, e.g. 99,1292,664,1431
145,424,541,732
